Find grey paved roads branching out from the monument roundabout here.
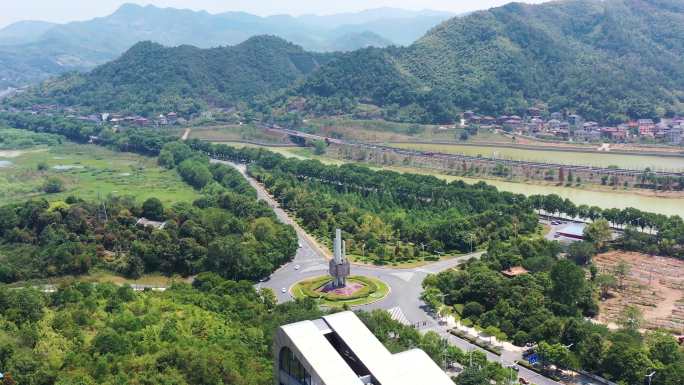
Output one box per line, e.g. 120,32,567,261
219,160,559,385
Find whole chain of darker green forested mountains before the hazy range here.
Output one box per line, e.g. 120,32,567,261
6,0,684,123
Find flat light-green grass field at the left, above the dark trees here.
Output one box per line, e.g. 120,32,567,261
0,129,199,205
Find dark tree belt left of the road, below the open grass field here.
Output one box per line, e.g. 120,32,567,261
0,149,297,283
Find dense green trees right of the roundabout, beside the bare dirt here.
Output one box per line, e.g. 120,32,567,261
423,238,684,385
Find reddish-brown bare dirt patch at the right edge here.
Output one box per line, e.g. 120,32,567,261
594,251,684,332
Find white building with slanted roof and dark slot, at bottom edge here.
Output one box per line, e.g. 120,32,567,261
273,311,453,385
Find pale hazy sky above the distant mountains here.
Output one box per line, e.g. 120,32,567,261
0,0,543,27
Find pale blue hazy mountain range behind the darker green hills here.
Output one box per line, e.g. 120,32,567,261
0,4,454,88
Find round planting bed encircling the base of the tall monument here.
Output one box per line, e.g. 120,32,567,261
291,275,389,307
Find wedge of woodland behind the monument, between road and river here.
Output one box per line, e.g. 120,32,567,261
249,159,537,264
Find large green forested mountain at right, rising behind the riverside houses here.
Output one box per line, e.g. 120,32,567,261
292,0,684,121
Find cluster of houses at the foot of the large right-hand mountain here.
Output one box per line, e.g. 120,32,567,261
463,108,684,145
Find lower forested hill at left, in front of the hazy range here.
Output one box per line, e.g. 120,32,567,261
16,36,329,115
